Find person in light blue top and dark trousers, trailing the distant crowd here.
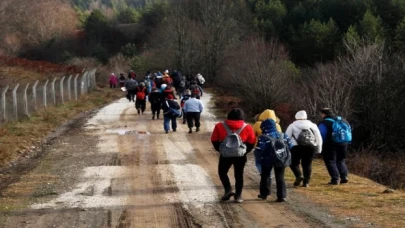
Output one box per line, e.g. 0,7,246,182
184,94,204,134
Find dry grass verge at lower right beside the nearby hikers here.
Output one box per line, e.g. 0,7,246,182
286,160,405,227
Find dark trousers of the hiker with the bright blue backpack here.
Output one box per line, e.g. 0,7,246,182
322,144,348,183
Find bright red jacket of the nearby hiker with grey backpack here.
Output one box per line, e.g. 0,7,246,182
211,120,256,152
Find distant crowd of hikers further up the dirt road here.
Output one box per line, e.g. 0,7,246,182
109,70,205,133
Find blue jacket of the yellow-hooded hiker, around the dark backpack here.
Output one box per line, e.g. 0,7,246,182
255,119,293,167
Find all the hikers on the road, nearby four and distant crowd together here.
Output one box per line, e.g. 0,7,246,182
110,70,352,203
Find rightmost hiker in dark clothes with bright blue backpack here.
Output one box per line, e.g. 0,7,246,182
318,108,352,185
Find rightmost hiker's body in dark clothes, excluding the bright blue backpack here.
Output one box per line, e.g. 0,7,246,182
318,108,350,185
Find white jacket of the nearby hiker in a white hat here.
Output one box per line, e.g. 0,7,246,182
285,120,322,153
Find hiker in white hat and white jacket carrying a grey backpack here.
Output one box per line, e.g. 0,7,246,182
285,111,322,187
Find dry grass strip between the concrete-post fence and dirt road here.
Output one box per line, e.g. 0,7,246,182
0,89,121,167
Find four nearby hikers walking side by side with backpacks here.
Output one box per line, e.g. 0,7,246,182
211,102,352,203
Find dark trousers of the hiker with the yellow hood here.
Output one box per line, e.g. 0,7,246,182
260,166,287,199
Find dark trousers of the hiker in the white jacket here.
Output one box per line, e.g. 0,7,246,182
290,146,316,184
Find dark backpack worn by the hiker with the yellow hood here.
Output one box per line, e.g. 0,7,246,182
262,133,291,167
